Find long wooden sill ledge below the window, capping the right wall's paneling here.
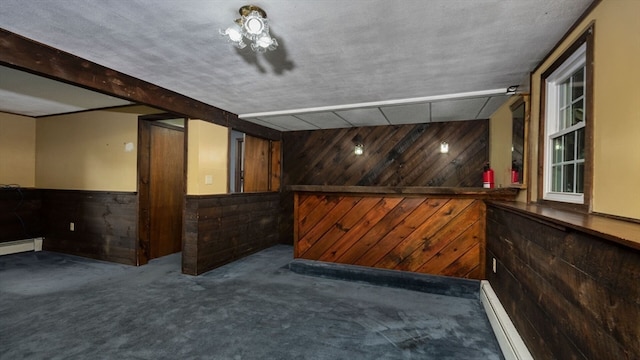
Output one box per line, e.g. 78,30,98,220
490,201,640,250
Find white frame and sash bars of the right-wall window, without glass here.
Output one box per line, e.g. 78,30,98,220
543,42,590,204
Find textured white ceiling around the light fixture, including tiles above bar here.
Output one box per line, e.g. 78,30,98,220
0,0,591,130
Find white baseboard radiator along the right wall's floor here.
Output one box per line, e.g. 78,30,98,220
480,280,533,360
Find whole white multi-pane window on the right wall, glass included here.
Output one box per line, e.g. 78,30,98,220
543,43,589,204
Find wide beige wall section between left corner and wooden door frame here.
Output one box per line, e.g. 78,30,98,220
35,111,139,191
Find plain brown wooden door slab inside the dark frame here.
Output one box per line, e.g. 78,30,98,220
148,125,184,259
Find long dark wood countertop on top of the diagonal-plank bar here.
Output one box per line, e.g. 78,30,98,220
286,185,518,200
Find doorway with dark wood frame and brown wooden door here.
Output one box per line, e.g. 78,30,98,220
137,114,186,265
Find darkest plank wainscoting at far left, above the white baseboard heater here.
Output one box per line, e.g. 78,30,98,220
0,186,43,242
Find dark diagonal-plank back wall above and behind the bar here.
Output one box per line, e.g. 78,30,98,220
283,120,489,187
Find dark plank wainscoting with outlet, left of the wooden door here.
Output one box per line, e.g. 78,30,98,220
41,190,138,265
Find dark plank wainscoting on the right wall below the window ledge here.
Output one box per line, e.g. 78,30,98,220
486,205,640,359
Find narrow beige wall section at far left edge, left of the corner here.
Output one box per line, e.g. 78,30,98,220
0,112,36,187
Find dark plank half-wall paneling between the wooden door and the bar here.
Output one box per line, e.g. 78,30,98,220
182,193,280,275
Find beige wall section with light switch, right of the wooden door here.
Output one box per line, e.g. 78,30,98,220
187,119,229,195
